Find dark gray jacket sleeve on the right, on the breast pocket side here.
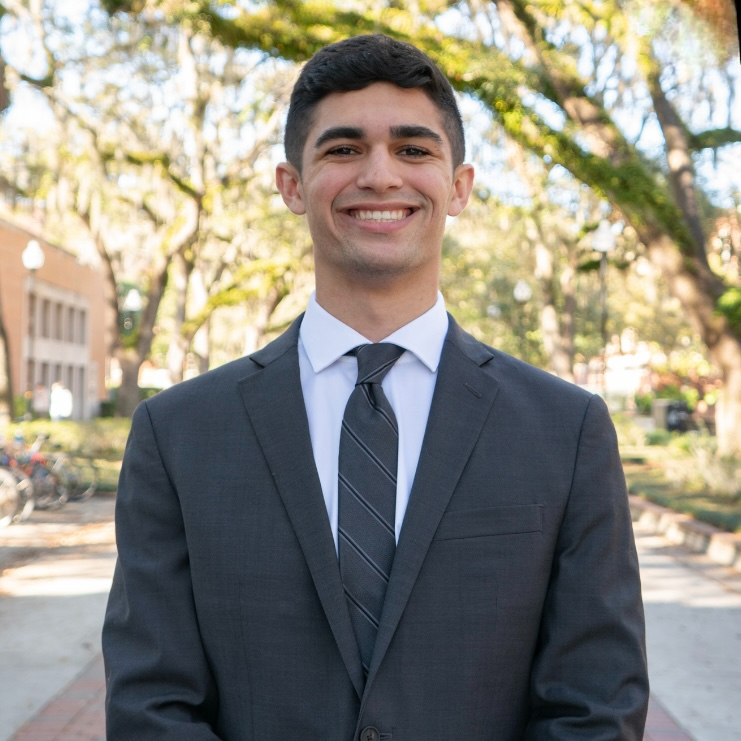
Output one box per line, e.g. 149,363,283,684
525,396,649,741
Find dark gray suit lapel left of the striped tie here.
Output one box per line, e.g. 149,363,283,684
239,317,363,696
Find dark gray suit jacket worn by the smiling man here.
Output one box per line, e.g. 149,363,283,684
103,320,648,741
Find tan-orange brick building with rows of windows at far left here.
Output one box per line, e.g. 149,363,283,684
0,218,107,419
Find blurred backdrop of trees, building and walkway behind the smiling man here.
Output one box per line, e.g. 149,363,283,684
0,0,741,741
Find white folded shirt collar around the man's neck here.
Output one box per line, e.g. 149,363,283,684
299,291,448,373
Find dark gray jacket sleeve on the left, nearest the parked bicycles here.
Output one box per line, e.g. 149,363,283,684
103,404,218,741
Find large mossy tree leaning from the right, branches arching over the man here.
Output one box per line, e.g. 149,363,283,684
102,0,741,453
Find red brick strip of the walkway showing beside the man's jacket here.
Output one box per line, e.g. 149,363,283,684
11,656,693,741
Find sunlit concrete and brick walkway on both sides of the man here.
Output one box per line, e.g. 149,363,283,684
0,498,741,741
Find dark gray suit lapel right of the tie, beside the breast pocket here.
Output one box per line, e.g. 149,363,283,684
366,317,499,689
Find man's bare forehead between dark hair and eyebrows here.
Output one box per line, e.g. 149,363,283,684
306,82,449,148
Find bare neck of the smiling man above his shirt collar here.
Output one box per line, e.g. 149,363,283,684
316,280,437,342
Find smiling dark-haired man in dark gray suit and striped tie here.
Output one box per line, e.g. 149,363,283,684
104,36,648,741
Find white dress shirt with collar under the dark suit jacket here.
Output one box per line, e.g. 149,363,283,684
298,293,448,548
